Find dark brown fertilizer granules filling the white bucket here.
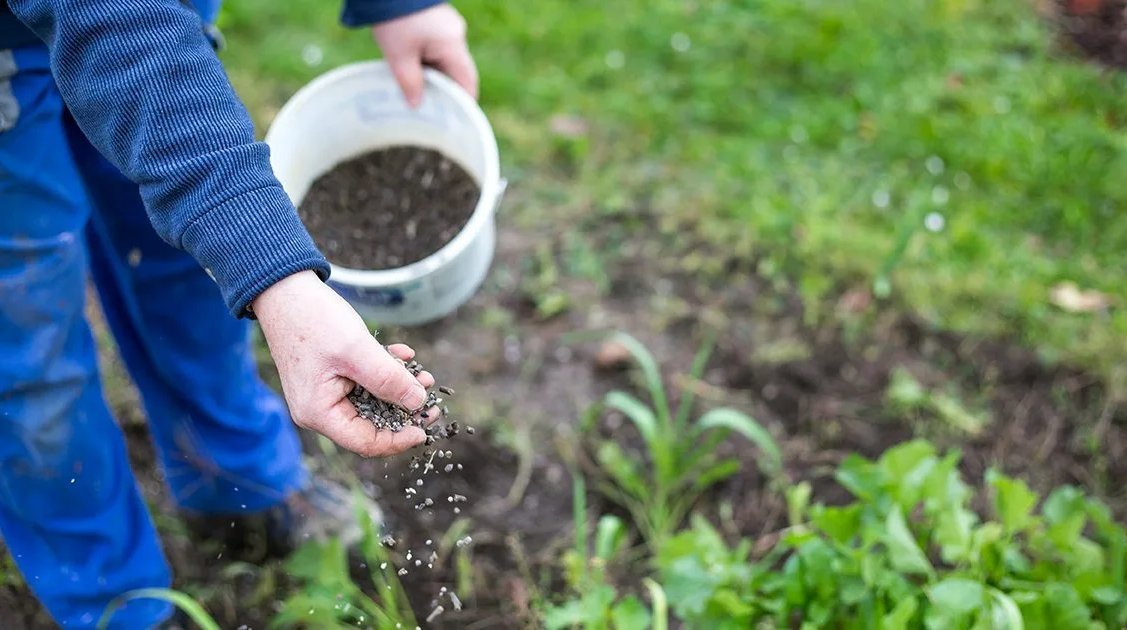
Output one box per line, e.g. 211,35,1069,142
298,147,481,269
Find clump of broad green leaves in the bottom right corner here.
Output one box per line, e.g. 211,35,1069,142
658,441,1127,630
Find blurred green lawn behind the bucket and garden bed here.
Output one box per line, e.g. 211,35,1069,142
222,0,1127,396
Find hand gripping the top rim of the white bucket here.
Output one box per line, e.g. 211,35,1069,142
372,3,478,108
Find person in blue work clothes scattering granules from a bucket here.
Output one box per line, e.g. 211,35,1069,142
0,0,478,629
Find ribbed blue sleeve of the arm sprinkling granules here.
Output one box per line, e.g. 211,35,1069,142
8,0,329,317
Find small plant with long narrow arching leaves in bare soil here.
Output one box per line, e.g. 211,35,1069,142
587,332,783,545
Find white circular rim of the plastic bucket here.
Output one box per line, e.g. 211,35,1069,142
265,60,505,289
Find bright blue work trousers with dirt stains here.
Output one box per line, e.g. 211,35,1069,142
0,46,308,629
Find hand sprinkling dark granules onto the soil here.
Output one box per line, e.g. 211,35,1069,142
250,272,438,456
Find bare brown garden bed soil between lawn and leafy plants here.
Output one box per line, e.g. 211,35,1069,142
0,209,1108,628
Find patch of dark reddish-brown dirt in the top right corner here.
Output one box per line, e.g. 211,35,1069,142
1055,0,1127,68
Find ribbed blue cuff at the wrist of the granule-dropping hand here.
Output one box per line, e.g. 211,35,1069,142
181,186,329,318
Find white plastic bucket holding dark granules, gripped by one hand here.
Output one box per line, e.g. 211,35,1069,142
266,61,506,326
